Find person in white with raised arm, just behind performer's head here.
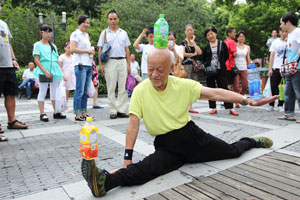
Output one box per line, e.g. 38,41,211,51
133,28,153,80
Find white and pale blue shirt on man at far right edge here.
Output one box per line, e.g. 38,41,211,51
287,28,300,69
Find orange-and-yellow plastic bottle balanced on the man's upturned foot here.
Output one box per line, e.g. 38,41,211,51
80,117,98,160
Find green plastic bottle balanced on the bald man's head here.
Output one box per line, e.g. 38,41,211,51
153,14,169,49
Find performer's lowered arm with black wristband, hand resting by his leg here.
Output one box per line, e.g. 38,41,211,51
123,114,140,168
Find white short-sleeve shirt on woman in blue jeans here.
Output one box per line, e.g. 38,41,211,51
70,29,92,66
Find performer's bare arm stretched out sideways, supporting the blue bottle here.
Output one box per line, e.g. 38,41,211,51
200,86,279,106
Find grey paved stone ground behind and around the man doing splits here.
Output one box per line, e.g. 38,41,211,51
0,98,300,199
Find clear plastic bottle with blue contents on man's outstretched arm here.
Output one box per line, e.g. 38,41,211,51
247,64,262,99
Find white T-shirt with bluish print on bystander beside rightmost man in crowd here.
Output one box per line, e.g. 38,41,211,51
270,39,286,69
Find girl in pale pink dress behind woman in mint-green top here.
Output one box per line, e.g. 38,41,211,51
58,42,76,112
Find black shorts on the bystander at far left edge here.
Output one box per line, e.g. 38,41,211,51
0,68,18,96
